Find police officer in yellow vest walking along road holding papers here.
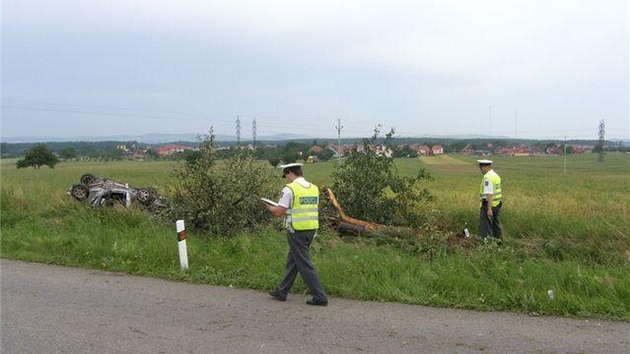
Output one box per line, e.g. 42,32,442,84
266,163,328,306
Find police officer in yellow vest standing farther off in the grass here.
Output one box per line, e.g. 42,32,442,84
477,160,503,245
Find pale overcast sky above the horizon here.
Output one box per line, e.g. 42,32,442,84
1,0,630,140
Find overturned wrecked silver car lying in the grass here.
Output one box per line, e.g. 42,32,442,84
67,173,166,208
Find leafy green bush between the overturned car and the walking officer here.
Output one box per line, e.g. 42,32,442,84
171,129,275,237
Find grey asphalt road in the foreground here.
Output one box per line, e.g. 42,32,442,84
0,259,630,354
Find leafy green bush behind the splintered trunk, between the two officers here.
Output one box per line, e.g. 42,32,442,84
332,126,432,227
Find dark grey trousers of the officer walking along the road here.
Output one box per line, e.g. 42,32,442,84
278,230,326,301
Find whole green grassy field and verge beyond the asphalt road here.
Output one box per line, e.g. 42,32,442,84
0,154,630,321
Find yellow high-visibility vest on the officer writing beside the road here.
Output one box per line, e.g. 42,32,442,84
287,182,319,230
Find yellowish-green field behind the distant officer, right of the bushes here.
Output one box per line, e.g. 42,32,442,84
423,154,630,264
